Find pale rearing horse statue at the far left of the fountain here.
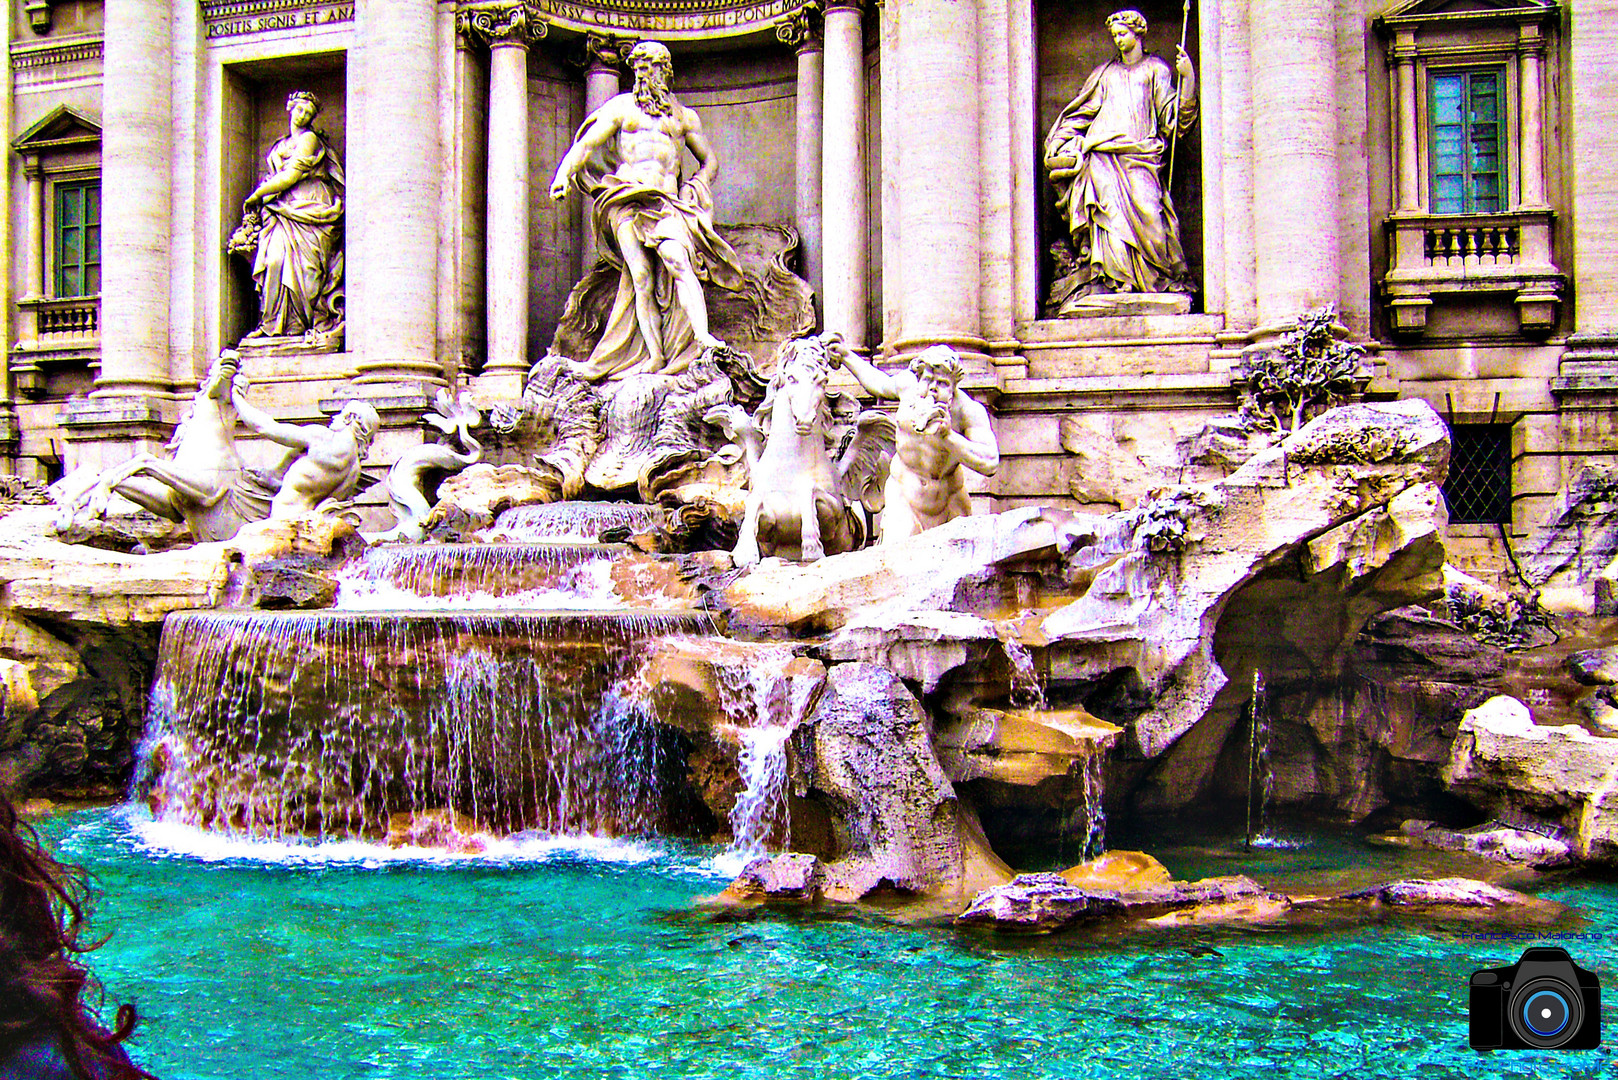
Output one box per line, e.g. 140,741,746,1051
57,350,269,541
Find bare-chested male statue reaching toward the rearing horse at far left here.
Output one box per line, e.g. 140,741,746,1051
231,393,382,521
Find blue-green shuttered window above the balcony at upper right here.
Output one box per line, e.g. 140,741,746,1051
1427,68,1506,214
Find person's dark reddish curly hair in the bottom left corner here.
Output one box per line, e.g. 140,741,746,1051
0,793,152,1080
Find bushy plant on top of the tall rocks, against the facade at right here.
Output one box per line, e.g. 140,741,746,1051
1246,306,1366,431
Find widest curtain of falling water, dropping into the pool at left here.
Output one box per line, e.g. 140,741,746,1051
138,612,705,839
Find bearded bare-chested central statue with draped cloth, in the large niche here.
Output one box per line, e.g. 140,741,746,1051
550,40,743,382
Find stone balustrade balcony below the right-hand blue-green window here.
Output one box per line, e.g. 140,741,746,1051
1382,207,1568,337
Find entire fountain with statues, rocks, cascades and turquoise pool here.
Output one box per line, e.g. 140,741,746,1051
0,5,1618,1077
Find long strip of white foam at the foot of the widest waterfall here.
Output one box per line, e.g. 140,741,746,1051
118,805,673,870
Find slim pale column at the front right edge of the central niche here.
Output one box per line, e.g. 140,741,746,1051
820,0,873,348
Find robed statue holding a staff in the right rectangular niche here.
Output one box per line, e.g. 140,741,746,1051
1045,10,1197,314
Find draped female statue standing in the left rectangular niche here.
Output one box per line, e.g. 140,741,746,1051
228,91,343,348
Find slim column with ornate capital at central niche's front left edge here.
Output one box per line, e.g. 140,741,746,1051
469,3,545,377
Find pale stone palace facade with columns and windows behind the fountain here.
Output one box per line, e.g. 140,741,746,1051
0,0,1618,573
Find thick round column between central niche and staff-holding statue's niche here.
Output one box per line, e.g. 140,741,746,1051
886,0,989,368
